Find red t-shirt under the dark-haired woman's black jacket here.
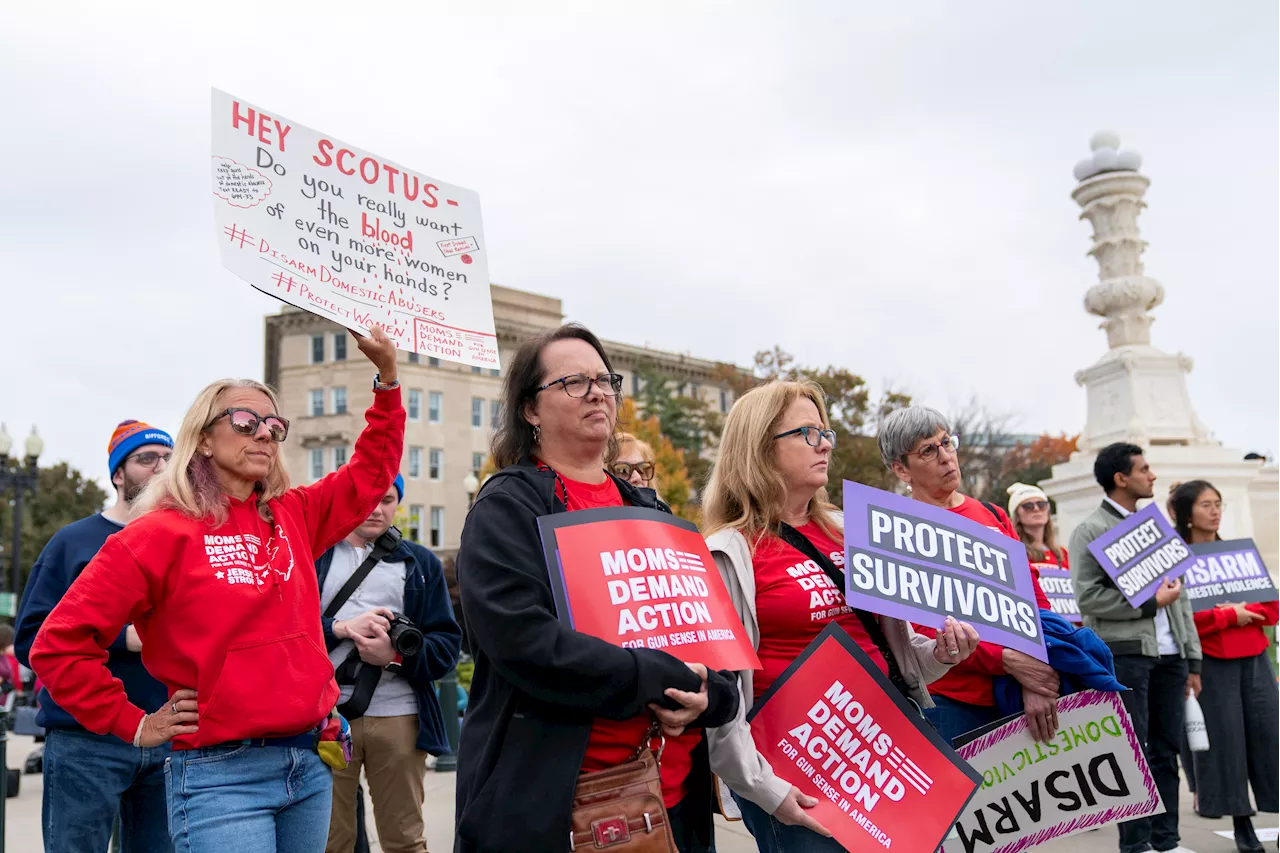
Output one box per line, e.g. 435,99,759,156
561,475,703,808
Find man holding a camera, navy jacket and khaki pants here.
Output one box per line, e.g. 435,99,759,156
316,475,462,853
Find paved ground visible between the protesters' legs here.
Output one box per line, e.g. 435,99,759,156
5,735,1276,853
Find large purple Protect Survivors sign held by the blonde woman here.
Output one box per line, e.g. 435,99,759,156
845,480,1048,662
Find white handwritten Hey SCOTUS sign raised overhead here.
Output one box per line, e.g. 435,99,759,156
211,88,498,369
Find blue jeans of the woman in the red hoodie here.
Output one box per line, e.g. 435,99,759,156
165,745,333,853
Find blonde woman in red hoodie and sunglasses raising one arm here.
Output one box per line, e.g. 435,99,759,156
31,328,404,853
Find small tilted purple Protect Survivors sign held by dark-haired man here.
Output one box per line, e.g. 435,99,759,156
1089,503,1193,607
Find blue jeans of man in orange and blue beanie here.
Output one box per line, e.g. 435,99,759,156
41,729,173,853
